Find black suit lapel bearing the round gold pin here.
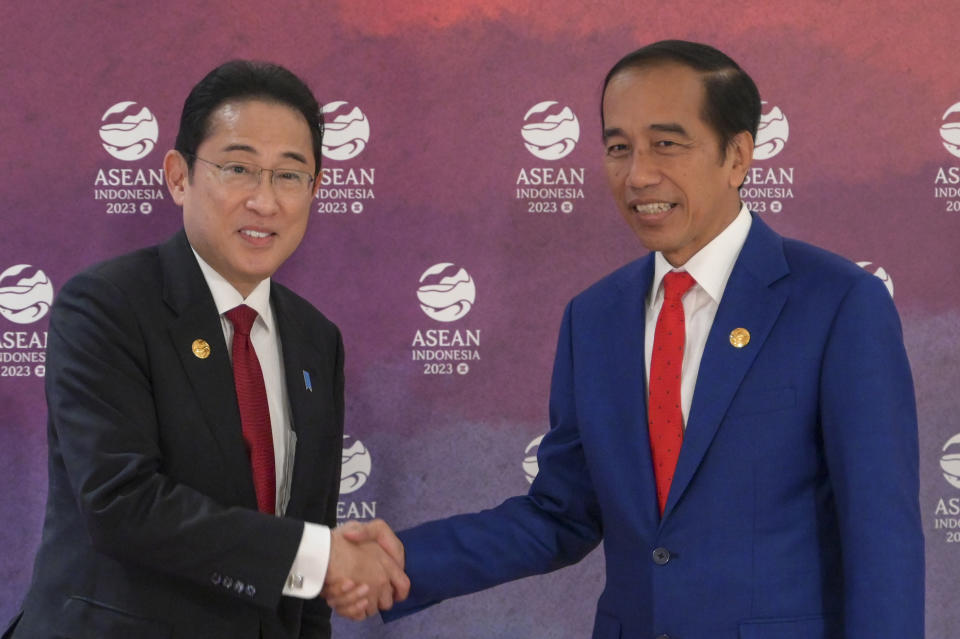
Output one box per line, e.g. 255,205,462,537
160,230,257,509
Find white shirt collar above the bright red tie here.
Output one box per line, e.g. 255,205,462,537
649,204,753,304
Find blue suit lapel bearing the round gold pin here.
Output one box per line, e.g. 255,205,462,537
663,215,789,519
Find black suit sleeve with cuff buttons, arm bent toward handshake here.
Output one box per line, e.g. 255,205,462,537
46,274,303,609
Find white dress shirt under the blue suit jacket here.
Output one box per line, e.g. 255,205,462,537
644,204,753,429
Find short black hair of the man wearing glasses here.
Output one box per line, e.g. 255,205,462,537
174,60,323,175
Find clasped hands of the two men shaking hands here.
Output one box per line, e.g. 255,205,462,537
320,519,410,621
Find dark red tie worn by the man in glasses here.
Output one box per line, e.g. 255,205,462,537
226,304,277,515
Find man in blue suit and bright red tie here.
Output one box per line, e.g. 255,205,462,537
331,41,924,639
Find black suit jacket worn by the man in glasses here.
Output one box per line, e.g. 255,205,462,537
6,231,343,639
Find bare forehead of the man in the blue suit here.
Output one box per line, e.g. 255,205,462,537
603,62,705,127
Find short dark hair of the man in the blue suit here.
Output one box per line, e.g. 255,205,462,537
600,40,761,157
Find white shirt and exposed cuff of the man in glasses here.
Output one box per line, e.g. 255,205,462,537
193,251,330,599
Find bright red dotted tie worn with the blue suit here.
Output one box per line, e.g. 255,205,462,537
647,271,696,515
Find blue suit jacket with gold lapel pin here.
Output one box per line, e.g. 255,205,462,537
386,216,924,639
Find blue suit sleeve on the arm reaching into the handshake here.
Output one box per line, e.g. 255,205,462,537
383,303,602,621
